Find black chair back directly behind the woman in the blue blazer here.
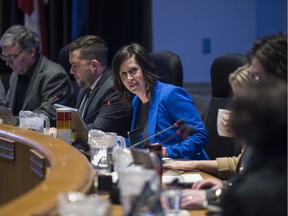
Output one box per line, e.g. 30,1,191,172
150,51,183,87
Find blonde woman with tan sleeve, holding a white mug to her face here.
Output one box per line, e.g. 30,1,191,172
163,64,252,179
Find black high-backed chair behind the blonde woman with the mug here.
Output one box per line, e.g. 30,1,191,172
202,53,248,160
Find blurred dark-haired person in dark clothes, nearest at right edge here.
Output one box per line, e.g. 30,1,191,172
218,78,287,216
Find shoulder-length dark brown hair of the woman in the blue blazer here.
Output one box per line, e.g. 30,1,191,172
112,43,158,104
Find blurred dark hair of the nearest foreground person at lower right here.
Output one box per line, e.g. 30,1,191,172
231,78,287,152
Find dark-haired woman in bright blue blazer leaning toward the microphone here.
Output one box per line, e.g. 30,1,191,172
112,43,208,160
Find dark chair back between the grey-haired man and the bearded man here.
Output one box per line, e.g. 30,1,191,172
57,46,79,102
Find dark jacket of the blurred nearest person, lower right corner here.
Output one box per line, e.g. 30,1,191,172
222,151,287,216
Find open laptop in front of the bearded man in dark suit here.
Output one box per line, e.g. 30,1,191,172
54,103,89,144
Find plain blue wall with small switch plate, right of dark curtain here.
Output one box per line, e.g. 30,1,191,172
152,0,287,83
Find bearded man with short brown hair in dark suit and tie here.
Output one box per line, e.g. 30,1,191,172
68,35,131,150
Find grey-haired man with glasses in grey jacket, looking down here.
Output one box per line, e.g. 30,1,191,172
0,25,73,126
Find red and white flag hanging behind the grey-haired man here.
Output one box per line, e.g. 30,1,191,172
18,0,48,56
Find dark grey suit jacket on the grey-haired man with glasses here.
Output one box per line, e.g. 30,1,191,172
7,55,73,126
